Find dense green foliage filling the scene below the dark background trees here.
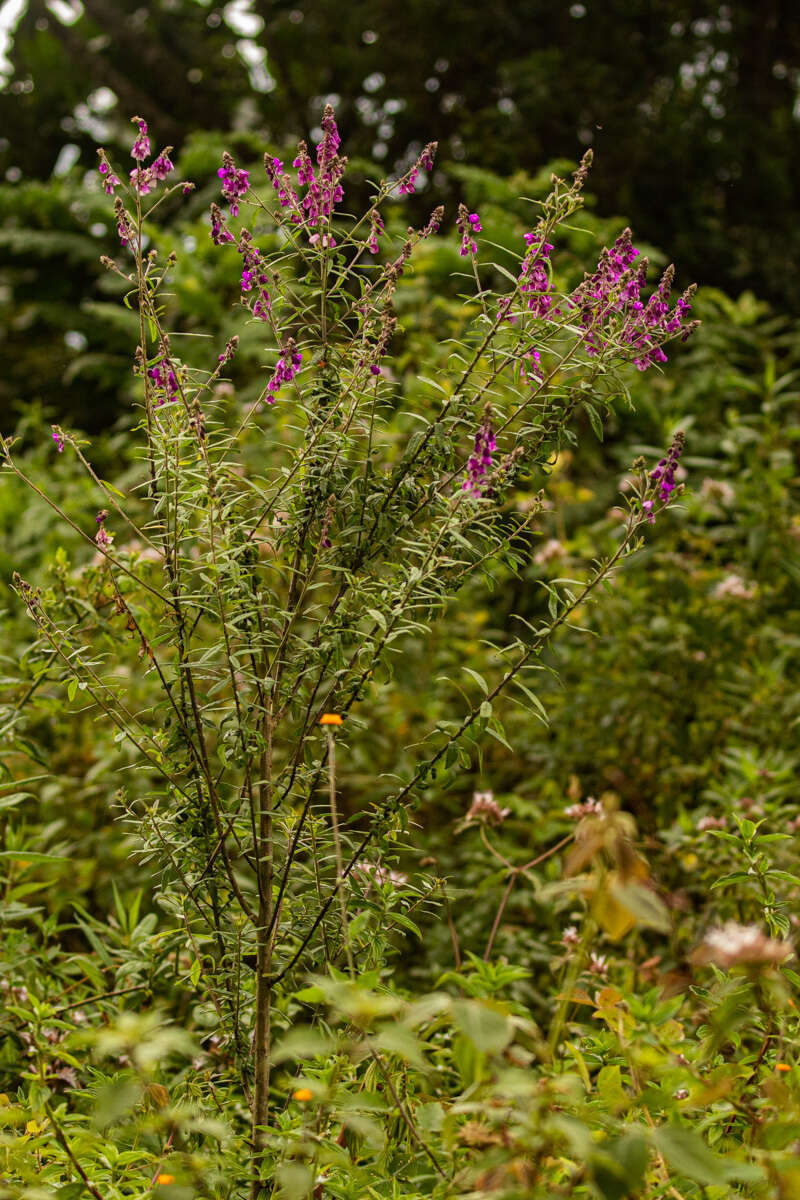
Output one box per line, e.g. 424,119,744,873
0,110,800,1200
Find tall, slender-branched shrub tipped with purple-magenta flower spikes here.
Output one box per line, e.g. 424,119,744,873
2,107,692,1196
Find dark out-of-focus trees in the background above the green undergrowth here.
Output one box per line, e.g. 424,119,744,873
0,0,800,432
